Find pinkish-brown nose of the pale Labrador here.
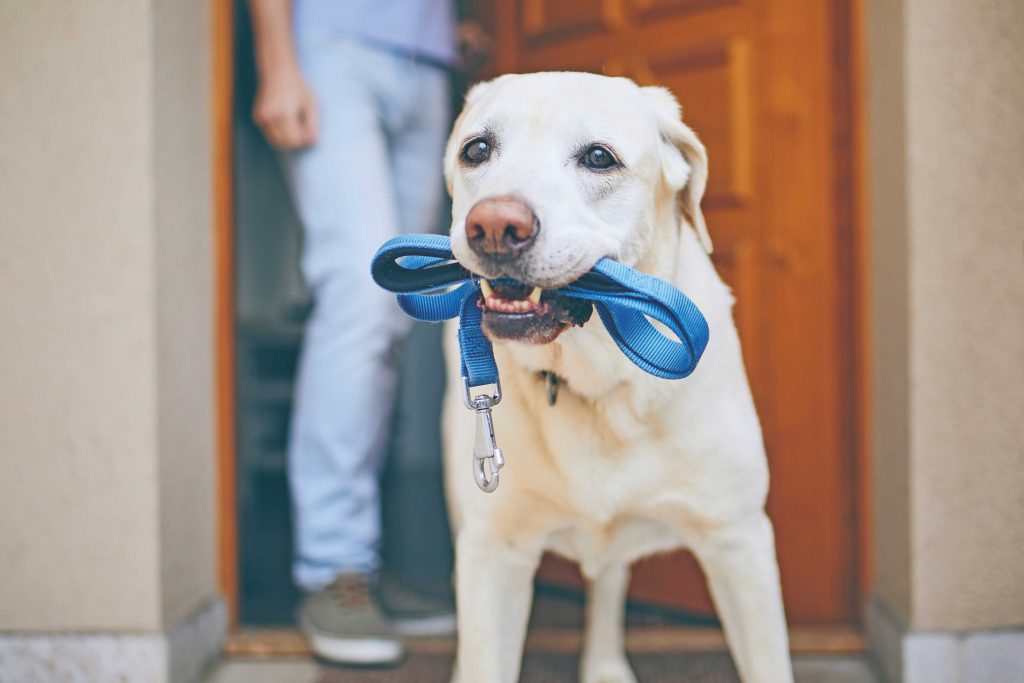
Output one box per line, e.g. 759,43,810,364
466,197,541,256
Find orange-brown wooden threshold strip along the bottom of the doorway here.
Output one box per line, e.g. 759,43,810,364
224,626,864,657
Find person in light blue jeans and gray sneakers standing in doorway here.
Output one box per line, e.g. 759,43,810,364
249,0,477,664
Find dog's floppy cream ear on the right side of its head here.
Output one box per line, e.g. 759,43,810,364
640,86,712,254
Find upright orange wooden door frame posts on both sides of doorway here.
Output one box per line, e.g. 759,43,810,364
210,0,873,630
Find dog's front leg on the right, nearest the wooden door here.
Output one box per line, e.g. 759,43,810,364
693,512,793,683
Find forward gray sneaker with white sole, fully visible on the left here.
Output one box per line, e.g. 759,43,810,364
299,573,402,665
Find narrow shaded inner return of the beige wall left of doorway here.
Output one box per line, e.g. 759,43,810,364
153,0,216,623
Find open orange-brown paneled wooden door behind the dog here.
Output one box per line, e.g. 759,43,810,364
482,0,860,625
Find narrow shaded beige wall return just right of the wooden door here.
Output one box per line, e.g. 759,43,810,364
866,0,910,614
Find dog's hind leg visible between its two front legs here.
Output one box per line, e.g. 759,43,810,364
580,564,636,683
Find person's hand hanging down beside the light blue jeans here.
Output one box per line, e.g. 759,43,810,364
253,67,318,150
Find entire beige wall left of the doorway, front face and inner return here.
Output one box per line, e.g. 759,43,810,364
0,0,214,631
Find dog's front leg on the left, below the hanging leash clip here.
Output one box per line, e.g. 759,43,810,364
453,524,541,683
